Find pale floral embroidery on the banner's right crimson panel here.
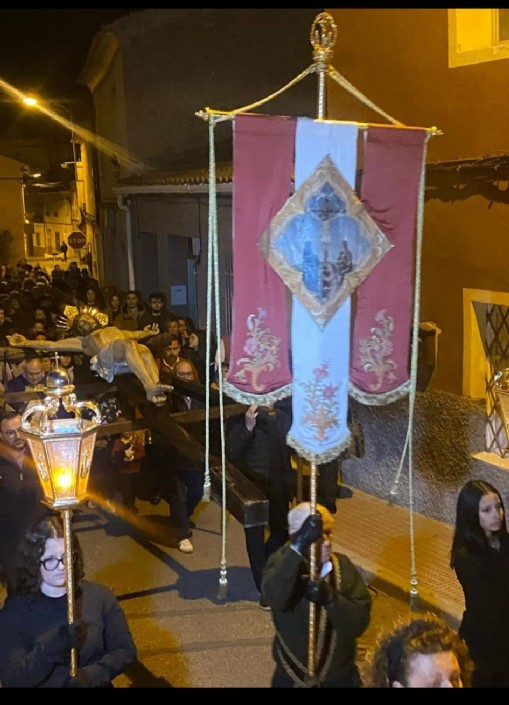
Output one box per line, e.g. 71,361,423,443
359,309,396,392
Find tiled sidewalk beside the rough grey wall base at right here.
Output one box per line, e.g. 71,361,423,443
333,488,464,627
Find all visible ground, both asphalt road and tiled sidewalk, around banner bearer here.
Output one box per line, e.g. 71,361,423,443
0,488,463,688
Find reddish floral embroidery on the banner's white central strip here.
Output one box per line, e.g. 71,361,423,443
302,362,339,441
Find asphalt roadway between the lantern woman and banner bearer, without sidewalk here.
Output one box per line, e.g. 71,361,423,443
75,492,416,688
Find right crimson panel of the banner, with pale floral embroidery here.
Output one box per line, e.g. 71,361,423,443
350,127,426,405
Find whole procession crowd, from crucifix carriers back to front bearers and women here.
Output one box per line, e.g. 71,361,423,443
0,262,509,688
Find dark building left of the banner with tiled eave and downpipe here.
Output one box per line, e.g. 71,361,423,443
80,9,318,328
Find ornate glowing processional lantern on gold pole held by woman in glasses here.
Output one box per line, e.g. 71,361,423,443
20,355,101,677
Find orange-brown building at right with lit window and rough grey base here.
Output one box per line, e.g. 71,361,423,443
328,8,509,523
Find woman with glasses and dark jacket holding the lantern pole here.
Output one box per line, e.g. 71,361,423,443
0,516,136,688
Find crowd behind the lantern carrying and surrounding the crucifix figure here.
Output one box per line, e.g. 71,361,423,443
0,254,215,553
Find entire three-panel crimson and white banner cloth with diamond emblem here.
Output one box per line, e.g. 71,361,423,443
223,115,426,464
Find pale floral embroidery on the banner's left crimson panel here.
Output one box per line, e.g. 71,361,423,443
235,308,281,392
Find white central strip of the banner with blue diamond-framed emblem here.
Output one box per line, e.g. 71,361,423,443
260,118,390,464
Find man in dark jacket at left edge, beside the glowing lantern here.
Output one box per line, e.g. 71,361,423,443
0,411,51,593
